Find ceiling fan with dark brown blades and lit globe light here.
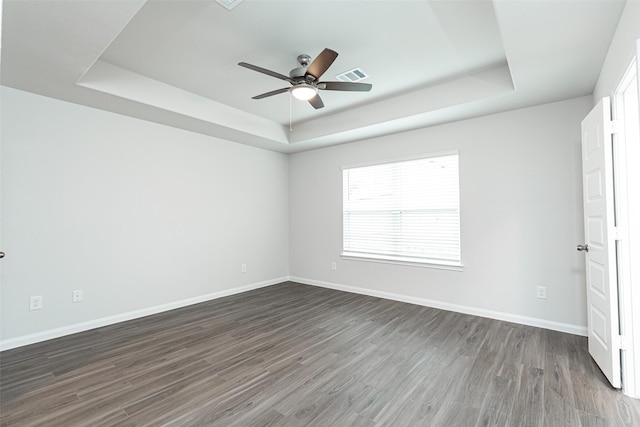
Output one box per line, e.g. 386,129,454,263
238,49,372,109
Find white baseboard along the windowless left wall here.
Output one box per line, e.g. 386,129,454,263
0,277,289,351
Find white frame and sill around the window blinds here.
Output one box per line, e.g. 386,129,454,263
340,150,464,271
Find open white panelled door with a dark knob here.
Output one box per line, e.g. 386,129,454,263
578,97,621,388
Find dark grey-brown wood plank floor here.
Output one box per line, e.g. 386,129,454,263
0,283,640,427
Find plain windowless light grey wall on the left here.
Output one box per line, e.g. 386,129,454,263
0,87,289,348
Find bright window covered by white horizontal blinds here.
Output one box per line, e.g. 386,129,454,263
342,152,462,268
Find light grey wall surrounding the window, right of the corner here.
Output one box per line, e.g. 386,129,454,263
290,97,591,334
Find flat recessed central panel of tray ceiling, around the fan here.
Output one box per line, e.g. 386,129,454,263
100,0,506,125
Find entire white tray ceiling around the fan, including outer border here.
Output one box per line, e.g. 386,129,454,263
1,0,624,152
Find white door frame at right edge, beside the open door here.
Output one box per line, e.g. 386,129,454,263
611,54,640,398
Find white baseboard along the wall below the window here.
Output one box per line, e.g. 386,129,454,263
289,277,587,336
